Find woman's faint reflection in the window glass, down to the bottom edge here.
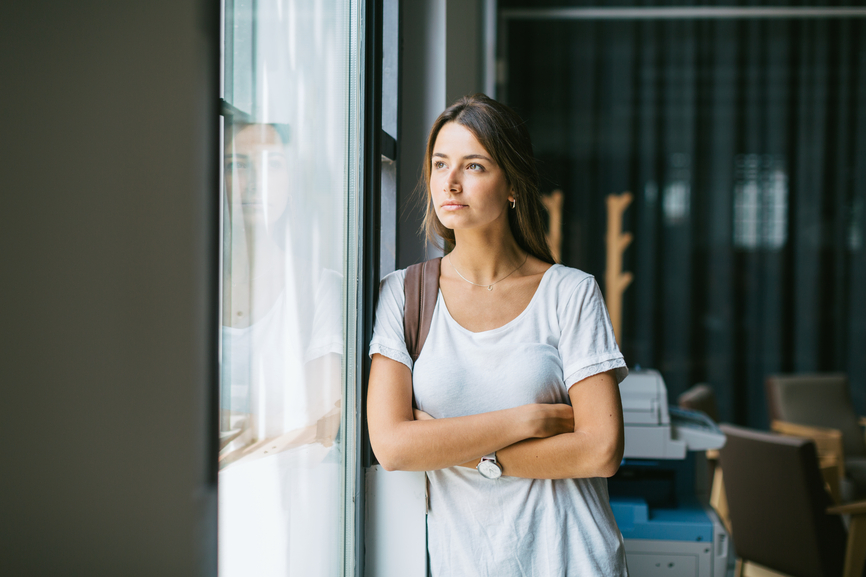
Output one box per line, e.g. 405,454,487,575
219,123,343,576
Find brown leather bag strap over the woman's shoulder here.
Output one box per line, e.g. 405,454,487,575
403,258,442,362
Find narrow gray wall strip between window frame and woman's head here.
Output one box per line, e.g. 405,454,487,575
397,0,484,268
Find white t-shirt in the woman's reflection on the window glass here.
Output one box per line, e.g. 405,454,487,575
219,270,343,577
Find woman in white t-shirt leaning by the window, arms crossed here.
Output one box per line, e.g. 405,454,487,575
368,95,627,576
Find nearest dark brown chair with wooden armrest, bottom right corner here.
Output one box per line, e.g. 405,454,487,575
720,425,866,577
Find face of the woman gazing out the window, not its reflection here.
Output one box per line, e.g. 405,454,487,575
430,122,514,231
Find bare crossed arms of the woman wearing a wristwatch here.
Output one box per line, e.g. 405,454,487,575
367,354,624,479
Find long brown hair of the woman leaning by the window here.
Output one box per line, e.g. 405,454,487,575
418,94,555,264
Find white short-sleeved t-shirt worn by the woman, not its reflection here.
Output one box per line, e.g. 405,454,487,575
370,265,628,577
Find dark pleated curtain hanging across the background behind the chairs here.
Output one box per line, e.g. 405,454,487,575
499,13,866,427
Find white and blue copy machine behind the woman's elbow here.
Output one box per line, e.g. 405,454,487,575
608,370,730,577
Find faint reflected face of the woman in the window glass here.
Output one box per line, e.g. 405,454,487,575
225,124,289,226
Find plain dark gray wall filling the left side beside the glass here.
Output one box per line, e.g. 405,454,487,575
0,0,217,576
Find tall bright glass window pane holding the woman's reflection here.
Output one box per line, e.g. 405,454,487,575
219,0,356,576
